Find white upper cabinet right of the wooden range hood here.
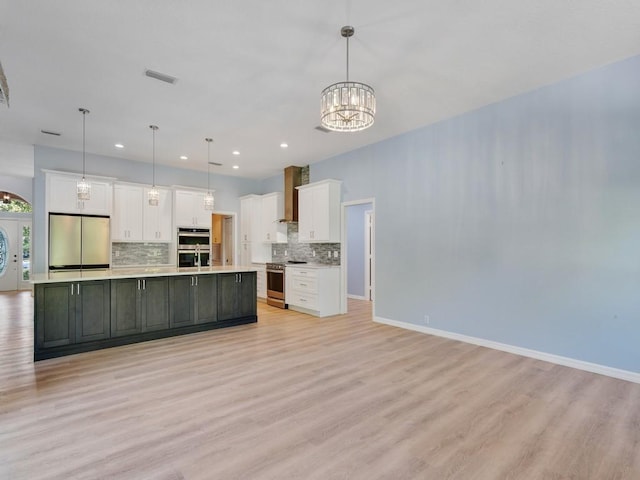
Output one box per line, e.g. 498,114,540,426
296,180,342,243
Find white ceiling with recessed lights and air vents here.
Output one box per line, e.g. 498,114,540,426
0,0,640,178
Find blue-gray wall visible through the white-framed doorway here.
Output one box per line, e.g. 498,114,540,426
345,203,373,297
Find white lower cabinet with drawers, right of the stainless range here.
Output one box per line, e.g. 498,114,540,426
285,265,340,317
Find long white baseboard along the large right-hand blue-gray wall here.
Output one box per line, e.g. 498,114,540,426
373,317,640,383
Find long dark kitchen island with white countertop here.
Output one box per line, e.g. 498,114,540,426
32,267,258,360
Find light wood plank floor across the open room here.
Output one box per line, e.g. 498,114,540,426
0,292,640,480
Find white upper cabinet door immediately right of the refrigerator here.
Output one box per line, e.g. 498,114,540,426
111,184,144,242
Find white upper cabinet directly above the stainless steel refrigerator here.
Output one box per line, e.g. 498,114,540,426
46,173,112,215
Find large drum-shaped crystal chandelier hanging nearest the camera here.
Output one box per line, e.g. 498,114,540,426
320,25,376,132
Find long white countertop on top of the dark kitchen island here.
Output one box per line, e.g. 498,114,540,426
31,265,257,283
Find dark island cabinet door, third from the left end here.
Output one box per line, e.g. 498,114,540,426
111,278,142,337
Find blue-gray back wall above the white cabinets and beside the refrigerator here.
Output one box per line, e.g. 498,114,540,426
33,146,261,272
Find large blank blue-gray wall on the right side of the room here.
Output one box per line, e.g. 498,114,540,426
304,57,640,372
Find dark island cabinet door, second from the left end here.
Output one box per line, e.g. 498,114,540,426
76,280,111,342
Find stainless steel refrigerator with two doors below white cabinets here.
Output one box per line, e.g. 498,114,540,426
49,213,111,270
